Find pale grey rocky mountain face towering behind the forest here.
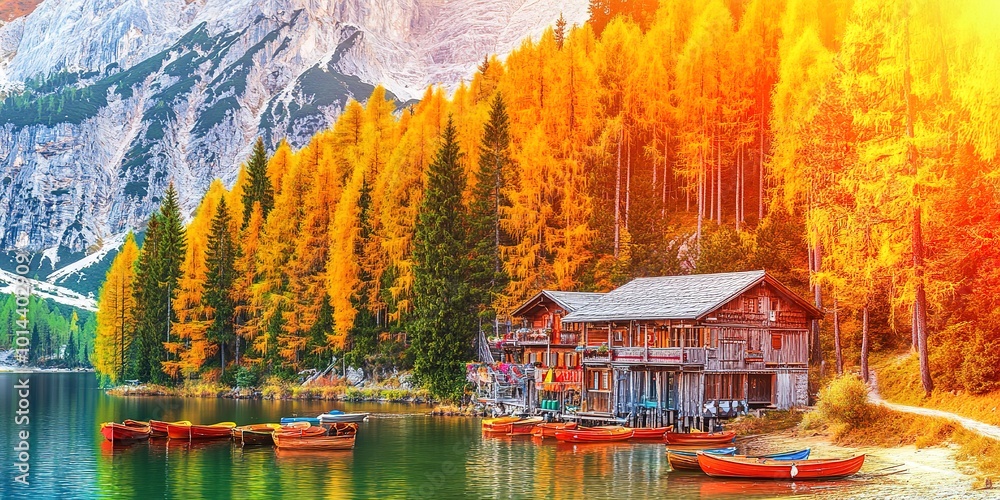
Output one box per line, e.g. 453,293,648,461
0,0,587,258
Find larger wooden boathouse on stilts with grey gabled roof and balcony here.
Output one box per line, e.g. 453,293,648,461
560,271,822,428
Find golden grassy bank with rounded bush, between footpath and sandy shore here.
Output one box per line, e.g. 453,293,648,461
800,375,1000,482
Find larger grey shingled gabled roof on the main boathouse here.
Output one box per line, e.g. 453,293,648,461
562,270,823,323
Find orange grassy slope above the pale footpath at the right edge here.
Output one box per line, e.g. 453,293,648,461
872,353,1000,425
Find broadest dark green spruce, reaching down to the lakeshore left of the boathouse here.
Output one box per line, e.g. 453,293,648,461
411,117,476,398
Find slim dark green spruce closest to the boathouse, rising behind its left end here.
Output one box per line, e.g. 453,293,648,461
469,92,511,332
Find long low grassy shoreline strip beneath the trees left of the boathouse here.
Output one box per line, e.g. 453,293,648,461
107,378,434,403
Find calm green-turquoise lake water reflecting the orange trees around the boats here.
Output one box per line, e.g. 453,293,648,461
0,373,868,500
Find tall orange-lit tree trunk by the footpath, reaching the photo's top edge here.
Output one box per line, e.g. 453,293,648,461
902,2,934,396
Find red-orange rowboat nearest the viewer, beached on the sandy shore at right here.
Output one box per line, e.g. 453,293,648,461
698,453,865,479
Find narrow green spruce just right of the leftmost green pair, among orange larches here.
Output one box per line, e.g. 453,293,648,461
202,197,239,374
